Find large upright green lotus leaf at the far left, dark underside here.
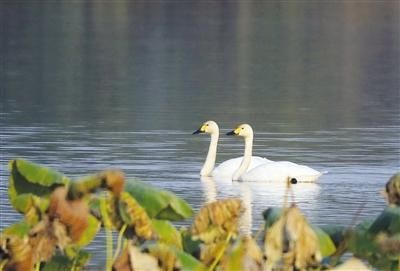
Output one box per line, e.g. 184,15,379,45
8,159,69,213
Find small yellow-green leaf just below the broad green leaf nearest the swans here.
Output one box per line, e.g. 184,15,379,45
151,219,182,249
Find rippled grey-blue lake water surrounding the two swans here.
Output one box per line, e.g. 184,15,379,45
0,1,400,268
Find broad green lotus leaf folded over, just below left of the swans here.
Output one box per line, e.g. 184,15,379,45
125,180,193,221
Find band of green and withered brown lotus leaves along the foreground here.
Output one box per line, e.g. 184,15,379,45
0,160,400,271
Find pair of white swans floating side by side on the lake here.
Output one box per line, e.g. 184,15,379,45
193,120,322,182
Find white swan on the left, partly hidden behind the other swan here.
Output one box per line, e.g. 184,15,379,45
193,120,269,178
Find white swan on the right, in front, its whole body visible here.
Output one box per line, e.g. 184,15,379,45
227,124,322,182
